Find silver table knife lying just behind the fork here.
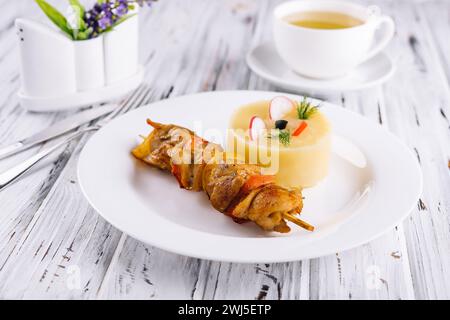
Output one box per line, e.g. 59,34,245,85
0,104,118,159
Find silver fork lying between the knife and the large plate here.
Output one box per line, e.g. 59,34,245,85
0,85,150,190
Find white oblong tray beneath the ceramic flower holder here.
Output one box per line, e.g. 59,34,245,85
17,66,144,112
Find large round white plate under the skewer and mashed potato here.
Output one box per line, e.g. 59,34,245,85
78,91,422,262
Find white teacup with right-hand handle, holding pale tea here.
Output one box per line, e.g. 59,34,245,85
273,0,395,79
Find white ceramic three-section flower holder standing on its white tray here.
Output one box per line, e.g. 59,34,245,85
15,15,142,106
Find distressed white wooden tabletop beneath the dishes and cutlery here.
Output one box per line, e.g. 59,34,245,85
0,0,450,299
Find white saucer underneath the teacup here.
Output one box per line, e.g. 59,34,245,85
247,43,395,93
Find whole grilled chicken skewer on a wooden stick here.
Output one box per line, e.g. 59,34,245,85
132,120,314,233
